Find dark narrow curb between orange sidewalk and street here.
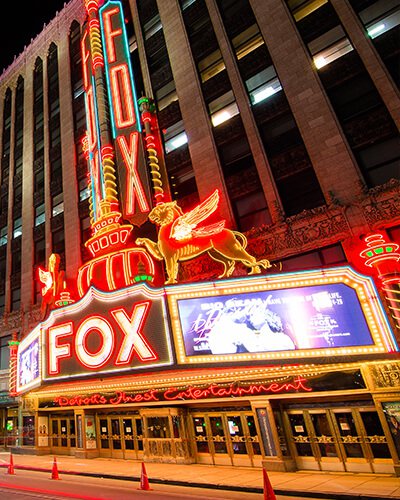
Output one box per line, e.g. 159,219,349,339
0,464,394,500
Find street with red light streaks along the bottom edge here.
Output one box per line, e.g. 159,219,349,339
0,470,334,500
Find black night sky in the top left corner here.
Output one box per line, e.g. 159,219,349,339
0,0,68,74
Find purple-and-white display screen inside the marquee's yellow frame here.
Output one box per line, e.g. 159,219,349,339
178,283,373,356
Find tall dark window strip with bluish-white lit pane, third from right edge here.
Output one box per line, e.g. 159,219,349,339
216,0,325,216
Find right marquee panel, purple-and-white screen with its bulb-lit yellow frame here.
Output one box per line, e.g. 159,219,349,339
168,267,397,363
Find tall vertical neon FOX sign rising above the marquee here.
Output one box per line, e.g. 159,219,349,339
82,0,151,226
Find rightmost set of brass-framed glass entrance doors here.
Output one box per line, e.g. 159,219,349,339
285,407,392,473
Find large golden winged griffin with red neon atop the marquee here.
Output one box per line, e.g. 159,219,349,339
136,190,271,285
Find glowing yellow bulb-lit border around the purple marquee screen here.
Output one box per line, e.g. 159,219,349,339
165,267,397,365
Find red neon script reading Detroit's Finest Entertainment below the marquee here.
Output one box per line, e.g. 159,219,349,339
50,376,312,407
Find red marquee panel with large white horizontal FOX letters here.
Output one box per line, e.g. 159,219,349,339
41,285,172,379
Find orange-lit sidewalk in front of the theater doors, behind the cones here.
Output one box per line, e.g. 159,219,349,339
0,452,400,500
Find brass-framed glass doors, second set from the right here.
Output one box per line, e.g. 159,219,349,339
190,412,262,467
